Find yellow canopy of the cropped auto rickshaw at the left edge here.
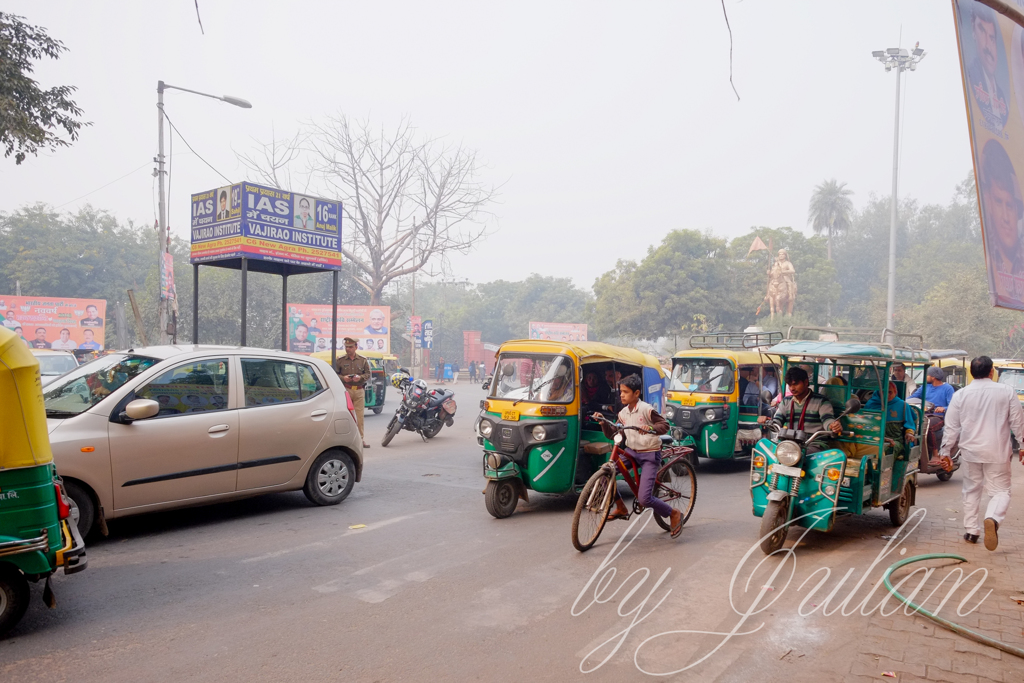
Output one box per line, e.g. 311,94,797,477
0,327,53,470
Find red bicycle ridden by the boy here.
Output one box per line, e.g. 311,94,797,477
572,419,697,552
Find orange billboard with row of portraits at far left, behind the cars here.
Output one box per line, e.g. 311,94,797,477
0,295,106,351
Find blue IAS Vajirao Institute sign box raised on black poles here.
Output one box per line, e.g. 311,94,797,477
189,182,341,270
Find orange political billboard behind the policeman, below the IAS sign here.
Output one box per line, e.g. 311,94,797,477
288,303,391,353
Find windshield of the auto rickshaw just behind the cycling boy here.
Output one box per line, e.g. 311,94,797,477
490,353,575,403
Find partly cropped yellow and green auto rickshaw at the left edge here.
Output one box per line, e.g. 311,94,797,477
0,328,86,637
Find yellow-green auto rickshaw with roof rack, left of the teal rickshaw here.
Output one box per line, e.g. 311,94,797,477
665,332,782,467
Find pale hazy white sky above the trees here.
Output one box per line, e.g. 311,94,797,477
0,0,971,287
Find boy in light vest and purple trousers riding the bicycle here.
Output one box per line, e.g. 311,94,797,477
594,375,683,538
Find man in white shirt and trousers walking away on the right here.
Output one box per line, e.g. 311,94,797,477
940,355,1024,550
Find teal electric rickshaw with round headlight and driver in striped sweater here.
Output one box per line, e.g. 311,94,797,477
751,330,932,554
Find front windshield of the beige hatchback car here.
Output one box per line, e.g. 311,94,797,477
43,353,159,418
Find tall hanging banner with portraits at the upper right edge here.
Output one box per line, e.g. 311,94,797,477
953,0,1024,310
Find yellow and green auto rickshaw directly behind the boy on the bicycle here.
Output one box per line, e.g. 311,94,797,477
476,340,665,519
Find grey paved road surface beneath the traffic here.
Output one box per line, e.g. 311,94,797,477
0,384,1020,683
